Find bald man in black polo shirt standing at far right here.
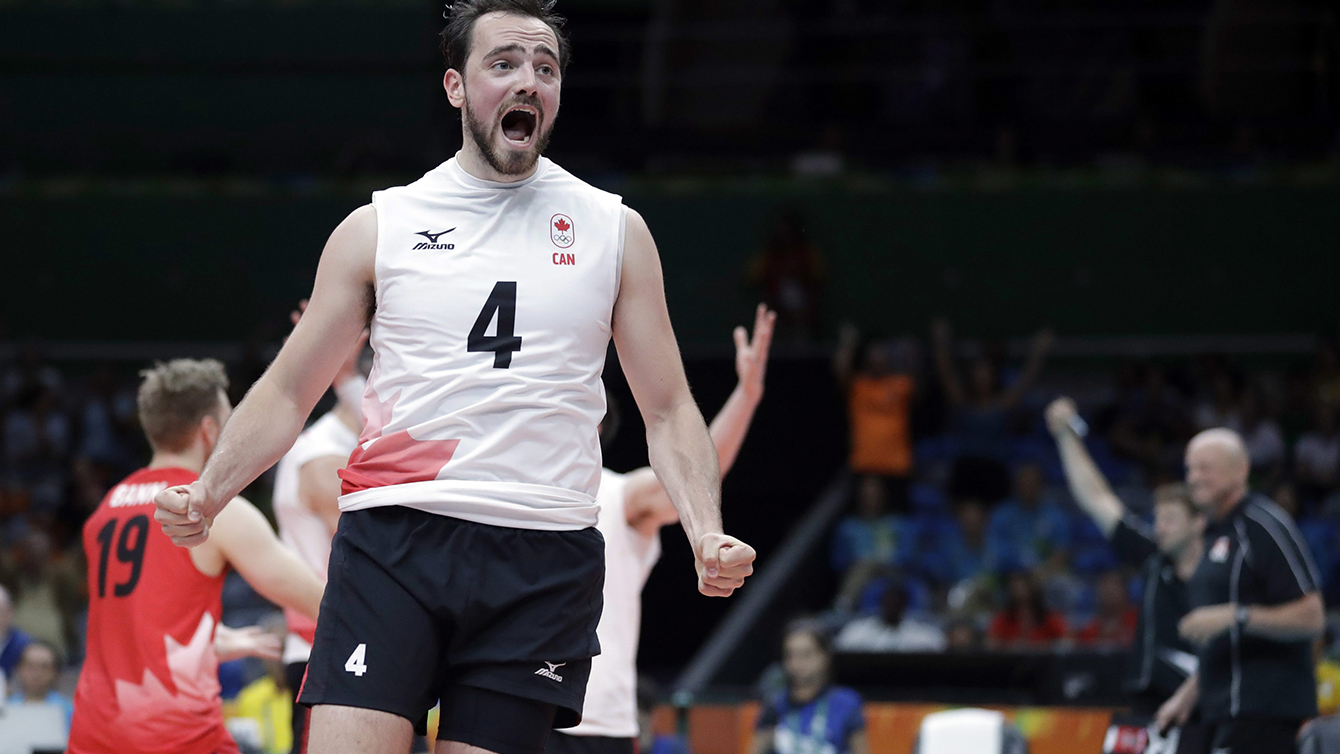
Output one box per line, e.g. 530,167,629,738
1159,429,1325,754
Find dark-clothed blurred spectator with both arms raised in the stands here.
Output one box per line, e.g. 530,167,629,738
931,319,1053,501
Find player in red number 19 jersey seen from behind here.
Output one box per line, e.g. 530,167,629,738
68,359,323,754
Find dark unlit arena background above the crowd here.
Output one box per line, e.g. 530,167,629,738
0,0,1340,675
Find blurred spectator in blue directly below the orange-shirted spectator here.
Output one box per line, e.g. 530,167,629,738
832,474,917,611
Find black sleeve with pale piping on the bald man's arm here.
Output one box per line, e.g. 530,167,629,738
1245,502,1321,605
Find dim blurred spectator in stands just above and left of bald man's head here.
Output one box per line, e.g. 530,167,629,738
1111,364,1191,479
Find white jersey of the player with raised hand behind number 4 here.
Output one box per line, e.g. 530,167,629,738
563,469,661,738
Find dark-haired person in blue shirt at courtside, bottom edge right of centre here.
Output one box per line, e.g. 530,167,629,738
750,620,867,754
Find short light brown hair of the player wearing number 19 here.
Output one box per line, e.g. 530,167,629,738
137,359,228,451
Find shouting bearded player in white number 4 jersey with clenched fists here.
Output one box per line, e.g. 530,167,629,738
155,0,754,754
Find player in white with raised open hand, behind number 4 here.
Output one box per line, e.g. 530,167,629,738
545,304,777,754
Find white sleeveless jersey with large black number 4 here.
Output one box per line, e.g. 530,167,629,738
340,158,624,530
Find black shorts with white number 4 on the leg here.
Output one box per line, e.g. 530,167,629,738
299,505,604,734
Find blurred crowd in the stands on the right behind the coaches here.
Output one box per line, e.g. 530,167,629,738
825,328,1340,652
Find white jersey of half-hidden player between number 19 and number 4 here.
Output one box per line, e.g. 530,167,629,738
273,411,358,664
